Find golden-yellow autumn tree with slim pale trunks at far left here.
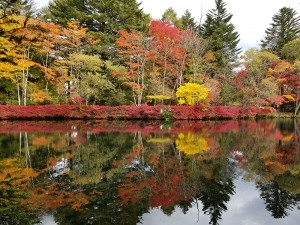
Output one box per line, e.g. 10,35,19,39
0,14,41,105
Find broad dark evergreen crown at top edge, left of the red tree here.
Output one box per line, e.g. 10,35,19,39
45,0,150,59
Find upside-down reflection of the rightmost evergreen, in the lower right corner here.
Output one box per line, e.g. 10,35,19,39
257,181,300,218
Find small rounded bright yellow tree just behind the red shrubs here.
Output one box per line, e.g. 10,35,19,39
176,83,209,105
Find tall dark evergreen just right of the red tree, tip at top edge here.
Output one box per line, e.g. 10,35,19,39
200,0,241,72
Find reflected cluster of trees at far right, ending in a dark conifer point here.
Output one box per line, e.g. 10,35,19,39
237,120,300,218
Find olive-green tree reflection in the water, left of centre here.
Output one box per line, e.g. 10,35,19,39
70,133,132,185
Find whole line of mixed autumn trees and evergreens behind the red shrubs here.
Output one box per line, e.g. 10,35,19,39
0,0,300,115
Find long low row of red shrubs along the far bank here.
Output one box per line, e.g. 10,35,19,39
0,105,275,120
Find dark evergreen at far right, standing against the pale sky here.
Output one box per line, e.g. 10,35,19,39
261,7,300,55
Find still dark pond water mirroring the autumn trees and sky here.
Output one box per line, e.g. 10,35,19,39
0,120,300,225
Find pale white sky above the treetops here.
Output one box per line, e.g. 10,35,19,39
35,0,300,49
